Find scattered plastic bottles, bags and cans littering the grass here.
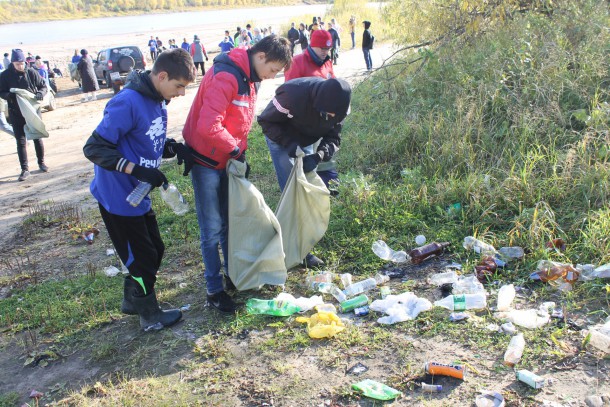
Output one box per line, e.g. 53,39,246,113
246,235,610,406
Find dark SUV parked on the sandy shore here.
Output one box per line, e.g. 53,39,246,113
93,45,146,88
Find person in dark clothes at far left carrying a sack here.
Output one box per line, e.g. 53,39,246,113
0,49,49,181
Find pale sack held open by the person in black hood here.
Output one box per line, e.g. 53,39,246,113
275,148,330,269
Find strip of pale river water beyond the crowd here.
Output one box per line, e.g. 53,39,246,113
0,5,329,48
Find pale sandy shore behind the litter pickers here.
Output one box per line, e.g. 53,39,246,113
0,22,390,247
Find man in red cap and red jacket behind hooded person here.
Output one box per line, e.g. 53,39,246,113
284,30,335,82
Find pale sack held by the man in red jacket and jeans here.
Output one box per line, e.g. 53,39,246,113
227,160,288,290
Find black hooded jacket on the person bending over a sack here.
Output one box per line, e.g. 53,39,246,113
258,77,351,161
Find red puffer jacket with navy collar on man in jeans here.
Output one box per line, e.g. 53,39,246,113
182,48,260,169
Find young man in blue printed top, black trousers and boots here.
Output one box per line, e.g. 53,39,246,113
83,48,195,330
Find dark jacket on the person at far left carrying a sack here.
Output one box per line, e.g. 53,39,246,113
0,64,47,119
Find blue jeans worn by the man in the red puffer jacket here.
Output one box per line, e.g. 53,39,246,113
191,165,229,295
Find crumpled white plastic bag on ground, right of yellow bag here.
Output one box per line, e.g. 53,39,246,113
369,292,432,324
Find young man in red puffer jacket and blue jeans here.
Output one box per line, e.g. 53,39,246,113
182,35,292,312
